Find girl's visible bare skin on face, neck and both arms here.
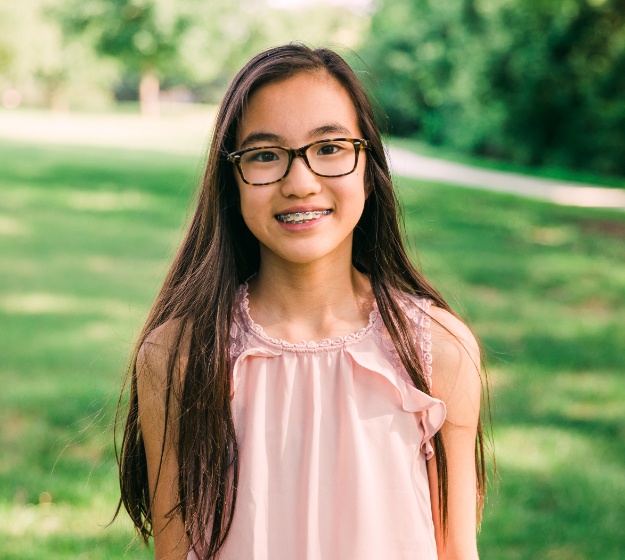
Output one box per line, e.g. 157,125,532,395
137,73,481,560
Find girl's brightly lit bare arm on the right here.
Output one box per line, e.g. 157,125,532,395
428,307,481,560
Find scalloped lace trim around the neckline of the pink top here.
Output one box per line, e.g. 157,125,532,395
239,282,380,352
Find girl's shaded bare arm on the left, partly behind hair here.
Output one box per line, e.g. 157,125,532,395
137,324,189,560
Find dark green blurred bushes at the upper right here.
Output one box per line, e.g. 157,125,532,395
364,0,625,174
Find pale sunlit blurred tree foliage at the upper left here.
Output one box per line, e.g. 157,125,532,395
13,0,369,105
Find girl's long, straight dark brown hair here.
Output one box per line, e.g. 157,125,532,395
117,44,486,559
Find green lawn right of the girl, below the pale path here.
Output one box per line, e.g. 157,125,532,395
402,177,625,560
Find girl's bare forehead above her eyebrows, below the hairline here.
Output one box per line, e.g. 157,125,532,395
237,72,360,145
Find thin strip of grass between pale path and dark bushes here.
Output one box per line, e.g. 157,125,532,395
389,137,625,189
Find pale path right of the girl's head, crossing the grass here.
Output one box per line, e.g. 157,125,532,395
389,147,625,210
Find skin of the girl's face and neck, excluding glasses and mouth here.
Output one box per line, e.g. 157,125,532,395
236,70,373,342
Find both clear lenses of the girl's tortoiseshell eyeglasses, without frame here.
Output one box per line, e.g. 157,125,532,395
240,140,356,184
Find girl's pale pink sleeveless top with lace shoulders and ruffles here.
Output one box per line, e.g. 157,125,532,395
189,284,445,560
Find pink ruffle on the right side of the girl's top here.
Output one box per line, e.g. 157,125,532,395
345,345,447,459
